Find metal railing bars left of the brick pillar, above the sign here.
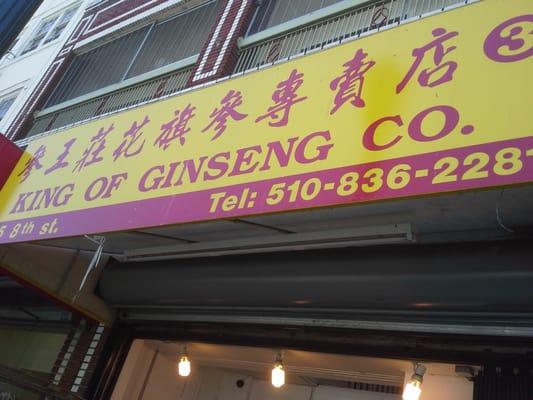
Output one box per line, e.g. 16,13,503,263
26,67,193,137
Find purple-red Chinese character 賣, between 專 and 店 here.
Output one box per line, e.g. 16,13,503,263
329,49,376,114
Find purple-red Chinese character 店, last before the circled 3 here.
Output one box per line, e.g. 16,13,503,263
396,28,459,93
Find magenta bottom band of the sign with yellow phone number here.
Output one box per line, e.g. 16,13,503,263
0,136,533,243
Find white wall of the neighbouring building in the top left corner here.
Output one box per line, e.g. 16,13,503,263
0,0,87,133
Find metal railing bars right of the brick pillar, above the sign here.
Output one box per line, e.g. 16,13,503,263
234,0,471,73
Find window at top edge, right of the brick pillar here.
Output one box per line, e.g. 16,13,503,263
248,0,341,35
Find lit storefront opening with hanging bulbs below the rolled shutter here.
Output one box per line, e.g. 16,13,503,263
111,340,470,400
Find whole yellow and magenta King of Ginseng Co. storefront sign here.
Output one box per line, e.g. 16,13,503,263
0,0,533,243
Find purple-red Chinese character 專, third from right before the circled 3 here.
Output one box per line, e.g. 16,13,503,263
255,69,307,127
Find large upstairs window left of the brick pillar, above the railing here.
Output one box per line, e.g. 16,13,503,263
46,0,224,107
